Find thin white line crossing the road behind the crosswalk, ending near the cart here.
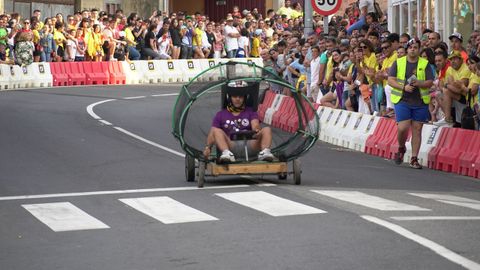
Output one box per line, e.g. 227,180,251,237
0,185,251,201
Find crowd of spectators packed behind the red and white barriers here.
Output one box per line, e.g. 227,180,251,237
0,0,480,128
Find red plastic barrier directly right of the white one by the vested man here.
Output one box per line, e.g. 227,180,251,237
434,128,475,172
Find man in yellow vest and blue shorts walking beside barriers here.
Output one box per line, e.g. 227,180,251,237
388,39,434,169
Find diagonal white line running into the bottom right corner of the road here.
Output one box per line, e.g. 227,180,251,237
361,216,480,270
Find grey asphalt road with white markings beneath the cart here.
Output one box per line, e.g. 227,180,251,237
0,85,480,270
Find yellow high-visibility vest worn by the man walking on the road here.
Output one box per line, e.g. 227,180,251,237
390,56,430,104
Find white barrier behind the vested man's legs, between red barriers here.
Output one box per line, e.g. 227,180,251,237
403,125,443,166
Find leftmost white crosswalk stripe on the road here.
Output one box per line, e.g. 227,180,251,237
22,202,110,232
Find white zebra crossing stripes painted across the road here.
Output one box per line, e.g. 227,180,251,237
22,190,480,232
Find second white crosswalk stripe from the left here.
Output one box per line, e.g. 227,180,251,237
119,197,218,224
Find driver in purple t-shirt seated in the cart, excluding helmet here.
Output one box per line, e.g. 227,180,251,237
203,93,274,163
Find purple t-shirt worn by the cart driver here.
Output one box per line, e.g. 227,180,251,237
212,107,258,138
